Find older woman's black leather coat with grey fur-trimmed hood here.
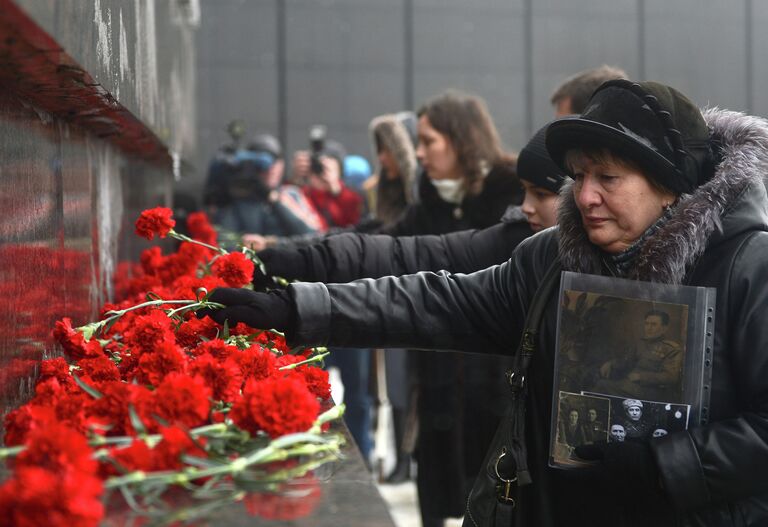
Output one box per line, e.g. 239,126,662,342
289,111,768,527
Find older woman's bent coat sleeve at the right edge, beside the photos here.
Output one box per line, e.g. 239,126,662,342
652,233,768,510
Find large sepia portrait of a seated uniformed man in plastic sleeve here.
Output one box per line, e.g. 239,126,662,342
558,290,688,402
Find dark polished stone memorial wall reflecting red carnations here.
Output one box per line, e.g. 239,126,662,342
0,1,184,413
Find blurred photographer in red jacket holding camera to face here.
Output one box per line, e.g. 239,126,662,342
293,125,363,229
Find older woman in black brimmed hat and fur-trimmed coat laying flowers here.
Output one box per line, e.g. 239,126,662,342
202,81,768,526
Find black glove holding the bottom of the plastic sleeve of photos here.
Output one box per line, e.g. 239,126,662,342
575,439,676,526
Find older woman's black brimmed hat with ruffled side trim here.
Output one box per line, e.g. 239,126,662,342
546,80,714,193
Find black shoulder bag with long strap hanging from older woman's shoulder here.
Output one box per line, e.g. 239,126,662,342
463,260,560,527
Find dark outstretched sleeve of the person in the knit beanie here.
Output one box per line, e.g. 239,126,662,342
300,222,531,282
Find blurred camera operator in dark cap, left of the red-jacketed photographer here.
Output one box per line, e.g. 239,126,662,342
209,134,323,240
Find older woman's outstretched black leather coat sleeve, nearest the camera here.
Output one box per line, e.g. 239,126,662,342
288,261,524,354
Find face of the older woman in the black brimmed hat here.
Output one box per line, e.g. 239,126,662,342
567,150,675,254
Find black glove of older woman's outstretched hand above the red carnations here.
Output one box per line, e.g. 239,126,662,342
197,287,294,333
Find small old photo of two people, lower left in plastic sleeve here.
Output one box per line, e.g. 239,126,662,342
551,392,611,466
